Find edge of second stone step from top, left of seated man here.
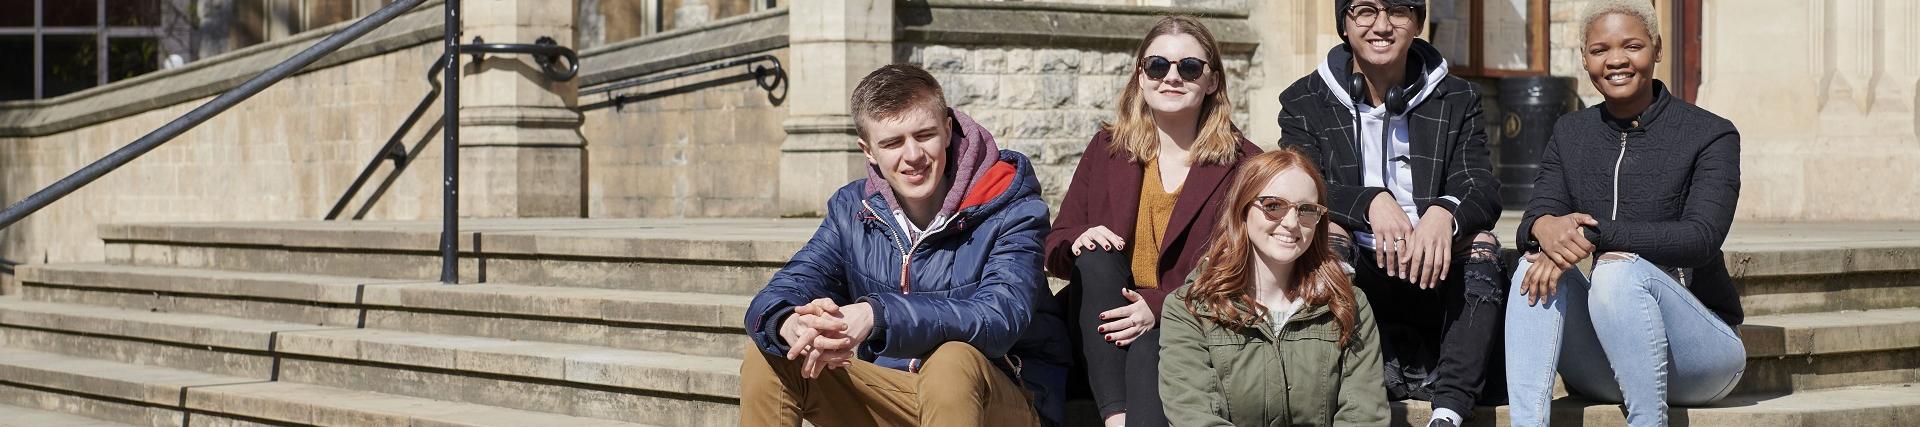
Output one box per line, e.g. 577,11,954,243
21,264,753,333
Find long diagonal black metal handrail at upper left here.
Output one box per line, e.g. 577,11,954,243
0,0,428,229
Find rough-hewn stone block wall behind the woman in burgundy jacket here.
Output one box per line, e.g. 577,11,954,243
895,44,1279,208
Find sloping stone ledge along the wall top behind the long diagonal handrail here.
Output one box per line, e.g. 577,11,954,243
0,0,444,137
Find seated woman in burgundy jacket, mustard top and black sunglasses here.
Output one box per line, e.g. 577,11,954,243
1046,15,1260,425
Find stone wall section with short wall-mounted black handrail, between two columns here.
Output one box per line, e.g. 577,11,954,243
580,10,793,217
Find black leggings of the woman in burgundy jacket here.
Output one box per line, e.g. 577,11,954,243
1068,250,1167,425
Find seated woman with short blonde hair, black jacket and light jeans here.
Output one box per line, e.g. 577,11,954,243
1507,0,1745,425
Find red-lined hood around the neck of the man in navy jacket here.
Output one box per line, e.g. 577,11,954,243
866,108,1033,217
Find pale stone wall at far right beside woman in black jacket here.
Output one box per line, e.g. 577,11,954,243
1699,0,1920,221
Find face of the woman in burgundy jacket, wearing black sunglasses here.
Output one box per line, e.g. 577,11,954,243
1133,33,1219,113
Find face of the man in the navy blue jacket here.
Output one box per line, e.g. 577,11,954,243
860,106,952,208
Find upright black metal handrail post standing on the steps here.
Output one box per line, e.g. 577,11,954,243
440,0,461,285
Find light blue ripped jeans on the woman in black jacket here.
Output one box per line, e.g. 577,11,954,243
1507,252,1747,427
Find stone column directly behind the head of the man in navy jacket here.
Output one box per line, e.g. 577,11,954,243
780,0,893,215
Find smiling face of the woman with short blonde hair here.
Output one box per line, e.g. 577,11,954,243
1582,13,1661,104
